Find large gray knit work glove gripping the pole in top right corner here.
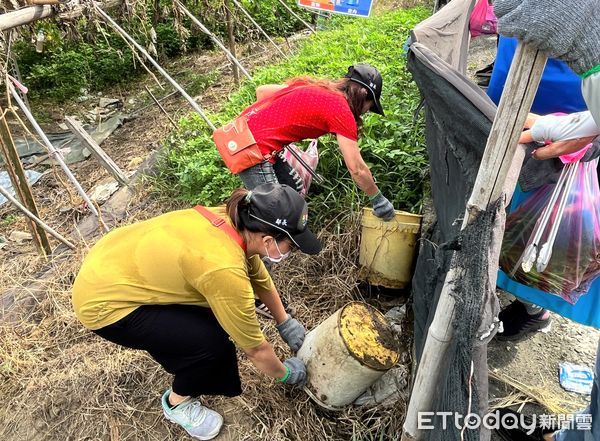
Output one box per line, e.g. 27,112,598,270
494,0,600,74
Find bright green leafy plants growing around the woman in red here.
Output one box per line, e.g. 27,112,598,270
161,8,428,223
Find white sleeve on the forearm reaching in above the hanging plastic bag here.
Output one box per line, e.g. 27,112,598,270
531,111,600,142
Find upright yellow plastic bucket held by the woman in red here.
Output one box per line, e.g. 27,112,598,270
358,208,422,289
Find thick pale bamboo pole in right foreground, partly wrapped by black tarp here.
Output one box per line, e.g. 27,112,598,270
402,43,546,441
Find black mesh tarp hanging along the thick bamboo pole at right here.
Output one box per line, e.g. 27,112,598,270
408,43,498,441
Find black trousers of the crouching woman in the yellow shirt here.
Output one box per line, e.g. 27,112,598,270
94,305,242,397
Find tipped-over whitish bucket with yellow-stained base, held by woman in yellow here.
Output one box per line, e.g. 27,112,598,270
298,302,400,410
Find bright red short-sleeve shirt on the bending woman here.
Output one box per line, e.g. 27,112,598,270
243,85,358,159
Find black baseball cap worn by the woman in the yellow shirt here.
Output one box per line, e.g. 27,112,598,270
242,184,321,254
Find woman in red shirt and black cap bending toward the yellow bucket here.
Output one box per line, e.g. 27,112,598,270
239,64,395,221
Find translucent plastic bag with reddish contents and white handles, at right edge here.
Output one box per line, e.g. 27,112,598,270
500,160,600,304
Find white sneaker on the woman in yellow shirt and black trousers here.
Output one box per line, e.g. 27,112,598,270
161,389,223,440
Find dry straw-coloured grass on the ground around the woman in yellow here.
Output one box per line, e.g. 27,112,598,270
0,211,405,441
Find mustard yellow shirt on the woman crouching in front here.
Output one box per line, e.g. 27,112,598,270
73,207,273,348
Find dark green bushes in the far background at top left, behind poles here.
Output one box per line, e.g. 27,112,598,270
14,0,311,101
